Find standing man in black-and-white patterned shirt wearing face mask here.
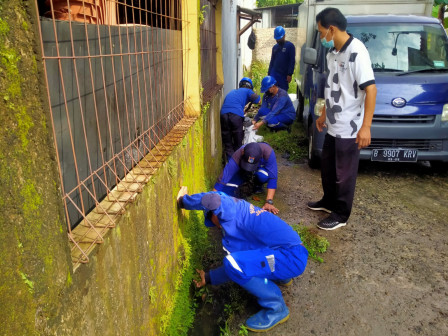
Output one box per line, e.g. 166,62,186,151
308,8,376,230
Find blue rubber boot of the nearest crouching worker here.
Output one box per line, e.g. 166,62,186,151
241,278,289,332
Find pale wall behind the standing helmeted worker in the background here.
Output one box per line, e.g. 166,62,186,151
252,28,297,63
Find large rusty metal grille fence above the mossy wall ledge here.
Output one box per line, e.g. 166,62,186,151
35,0,184,262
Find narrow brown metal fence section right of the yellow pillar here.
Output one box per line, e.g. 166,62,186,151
199,0,219,101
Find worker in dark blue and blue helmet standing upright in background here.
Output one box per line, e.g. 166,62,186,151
268,26,296,92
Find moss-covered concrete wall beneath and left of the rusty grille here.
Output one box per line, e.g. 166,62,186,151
0,0,221,335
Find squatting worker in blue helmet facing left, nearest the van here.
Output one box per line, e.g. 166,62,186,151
252,76,296,131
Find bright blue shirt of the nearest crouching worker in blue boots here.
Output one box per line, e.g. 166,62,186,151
182,192,302,253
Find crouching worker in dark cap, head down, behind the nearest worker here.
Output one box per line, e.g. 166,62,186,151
214,142,278,215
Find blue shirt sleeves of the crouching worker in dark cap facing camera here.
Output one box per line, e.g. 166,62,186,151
215,142,278,191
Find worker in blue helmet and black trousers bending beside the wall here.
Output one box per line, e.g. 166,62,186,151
221,77,260,159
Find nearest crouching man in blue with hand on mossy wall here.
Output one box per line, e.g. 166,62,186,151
178,187,308,332
